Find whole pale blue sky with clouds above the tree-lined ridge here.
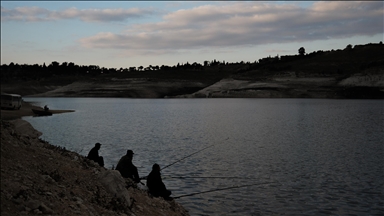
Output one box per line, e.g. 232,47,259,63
1,1,384,69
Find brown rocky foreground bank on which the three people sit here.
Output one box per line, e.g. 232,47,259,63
1,119,188,216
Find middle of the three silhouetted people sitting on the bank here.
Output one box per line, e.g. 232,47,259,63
116,150,140,183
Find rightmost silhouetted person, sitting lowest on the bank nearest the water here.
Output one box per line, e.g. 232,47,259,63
147,164,172,199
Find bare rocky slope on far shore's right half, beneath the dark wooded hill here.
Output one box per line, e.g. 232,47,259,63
178,69,384,99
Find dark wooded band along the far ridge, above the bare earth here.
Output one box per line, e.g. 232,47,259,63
0,42,384,83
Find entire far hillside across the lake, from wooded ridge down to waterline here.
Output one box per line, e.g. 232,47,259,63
1,43,384,99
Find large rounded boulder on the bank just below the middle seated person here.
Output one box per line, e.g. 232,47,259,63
99,170,131,206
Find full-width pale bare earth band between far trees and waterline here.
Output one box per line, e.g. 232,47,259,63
9,69,384,99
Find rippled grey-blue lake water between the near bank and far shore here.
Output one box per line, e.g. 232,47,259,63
24,98,384,215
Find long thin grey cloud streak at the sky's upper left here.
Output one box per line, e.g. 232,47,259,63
1,7,156,22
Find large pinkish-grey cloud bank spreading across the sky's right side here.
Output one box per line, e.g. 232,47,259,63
79,1,383,51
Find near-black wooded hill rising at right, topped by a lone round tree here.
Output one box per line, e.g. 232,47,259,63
231,42,384,80
